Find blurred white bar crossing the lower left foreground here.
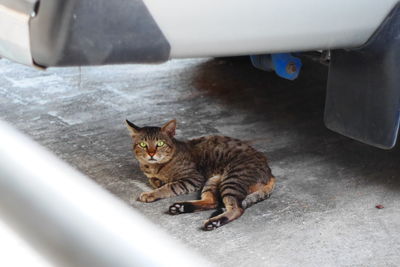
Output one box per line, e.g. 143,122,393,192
0,121,210,267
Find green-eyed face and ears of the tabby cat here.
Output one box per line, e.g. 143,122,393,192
126,120,176,164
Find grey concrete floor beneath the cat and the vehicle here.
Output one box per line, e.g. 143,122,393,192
0,58,400,266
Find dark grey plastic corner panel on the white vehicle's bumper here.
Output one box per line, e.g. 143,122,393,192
30,0,170,67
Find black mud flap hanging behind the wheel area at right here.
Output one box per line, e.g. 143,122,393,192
325,4,400,149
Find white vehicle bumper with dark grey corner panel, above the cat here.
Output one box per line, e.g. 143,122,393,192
0,0,398,67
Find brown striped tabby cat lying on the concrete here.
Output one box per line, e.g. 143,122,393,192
126,120,275,230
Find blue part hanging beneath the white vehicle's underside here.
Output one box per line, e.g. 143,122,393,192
250,53,303,80
